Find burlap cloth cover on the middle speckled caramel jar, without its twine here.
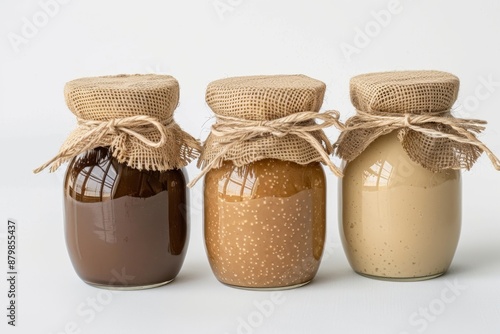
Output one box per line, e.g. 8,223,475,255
193,75,342,181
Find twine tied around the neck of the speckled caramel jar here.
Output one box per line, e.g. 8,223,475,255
188,110,343,188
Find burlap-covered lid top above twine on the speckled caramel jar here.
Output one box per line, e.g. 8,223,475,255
205,74,326,121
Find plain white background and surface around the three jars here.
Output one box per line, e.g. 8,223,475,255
0,0,500,334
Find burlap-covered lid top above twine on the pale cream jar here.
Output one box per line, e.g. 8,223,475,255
350,71,459,114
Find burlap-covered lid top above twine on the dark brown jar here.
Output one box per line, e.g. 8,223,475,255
64,74,179,121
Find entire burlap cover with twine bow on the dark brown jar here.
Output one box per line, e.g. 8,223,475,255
35,74,201,172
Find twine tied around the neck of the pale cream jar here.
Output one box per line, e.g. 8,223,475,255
345,110,500,170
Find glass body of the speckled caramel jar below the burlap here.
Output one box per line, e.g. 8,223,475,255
204,159,326,289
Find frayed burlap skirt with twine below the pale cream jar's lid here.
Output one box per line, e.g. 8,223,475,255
335,111,500,172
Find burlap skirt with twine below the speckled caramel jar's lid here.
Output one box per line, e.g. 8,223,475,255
188,110,343,187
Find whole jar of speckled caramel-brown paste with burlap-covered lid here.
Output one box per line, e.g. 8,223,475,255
200,75,338,289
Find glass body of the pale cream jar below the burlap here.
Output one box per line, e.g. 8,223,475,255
339,132,461,280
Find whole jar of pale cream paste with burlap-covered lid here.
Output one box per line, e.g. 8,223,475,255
338,71,472,281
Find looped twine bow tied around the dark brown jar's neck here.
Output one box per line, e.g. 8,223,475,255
33,115,174,173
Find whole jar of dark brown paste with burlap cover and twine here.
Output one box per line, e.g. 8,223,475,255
35,75,200,290
